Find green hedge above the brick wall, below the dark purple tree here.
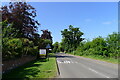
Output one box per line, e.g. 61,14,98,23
2,38,38,59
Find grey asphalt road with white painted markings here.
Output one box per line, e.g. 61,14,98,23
56,53,118,78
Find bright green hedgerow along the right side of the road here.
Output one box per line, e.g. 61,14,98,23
69,32,120,59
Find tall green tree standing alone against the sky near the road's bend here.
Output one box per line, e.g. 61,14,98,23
61,25,84,52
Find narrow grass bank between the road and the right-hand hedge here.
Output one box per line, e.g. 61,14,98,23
68,53,118,64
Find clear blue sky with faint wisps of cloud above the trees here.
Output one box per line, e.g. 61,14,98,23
2,2,118,42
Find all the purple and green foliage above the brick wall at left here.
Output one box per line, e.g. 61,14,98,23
0,2,52,60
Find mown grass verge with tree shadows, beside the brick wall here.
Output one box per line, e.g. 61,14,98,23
3,53,57,80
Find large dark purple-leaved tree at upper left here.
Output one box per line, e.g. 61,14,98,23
1,2,39,38
